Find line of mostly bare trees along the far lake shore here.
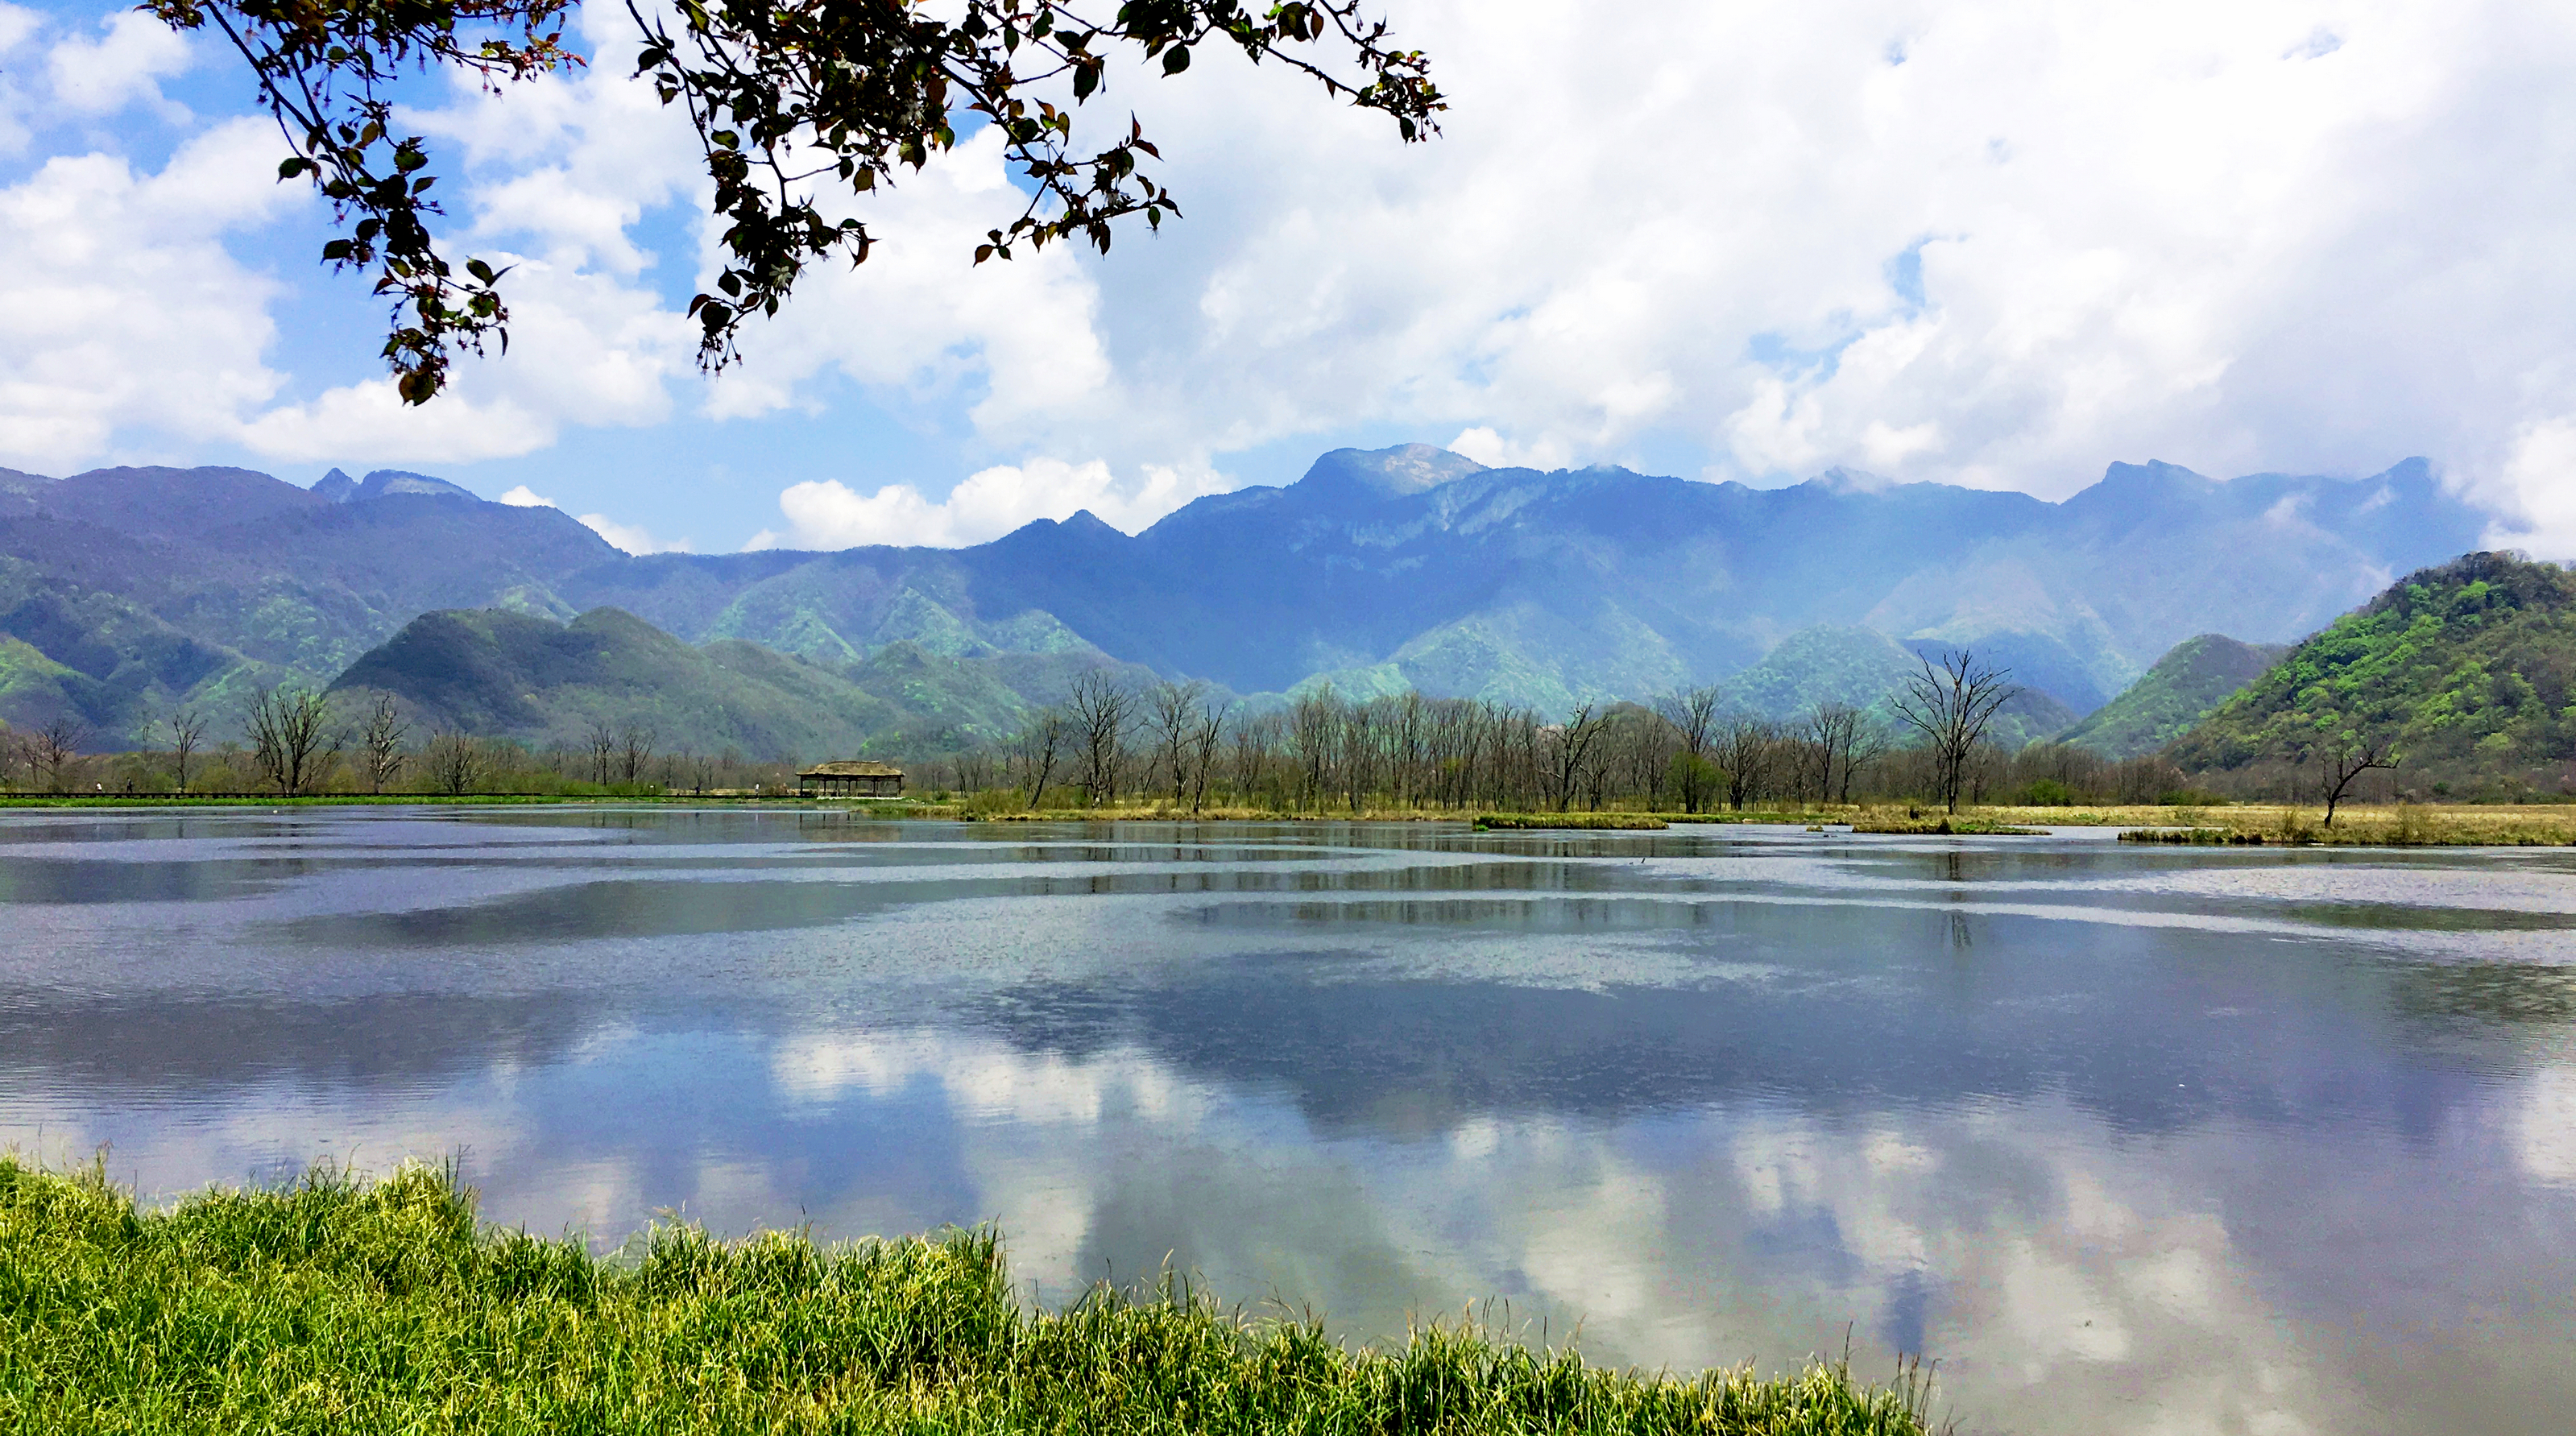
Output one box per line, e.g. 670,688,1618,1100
0,654,2452,816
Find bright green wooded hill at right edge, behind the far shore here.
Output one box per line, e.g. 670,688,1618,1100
2169,553,2576,792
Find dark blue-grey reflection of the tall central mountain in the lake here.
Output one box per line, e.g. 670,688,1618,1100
971,908,2393,1135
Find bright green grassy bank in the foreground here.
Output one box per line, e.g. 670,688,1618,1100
0,1156,1927,1436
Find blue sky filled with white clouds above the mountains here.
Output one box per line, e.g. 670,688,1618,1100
0,0,2576,558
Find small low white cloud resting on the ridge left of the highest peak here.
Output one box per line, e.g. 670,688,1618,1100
750,458,1228,548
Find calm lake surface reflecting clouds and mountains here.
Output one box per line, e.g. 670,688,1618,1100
0,811,2576,1434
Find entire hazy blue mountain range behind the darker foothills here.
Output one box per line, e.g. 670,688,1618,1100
0,445,2488,767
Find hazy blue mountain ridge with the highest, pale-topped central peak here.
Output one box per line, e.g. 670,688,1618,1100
564,445,2486,713
